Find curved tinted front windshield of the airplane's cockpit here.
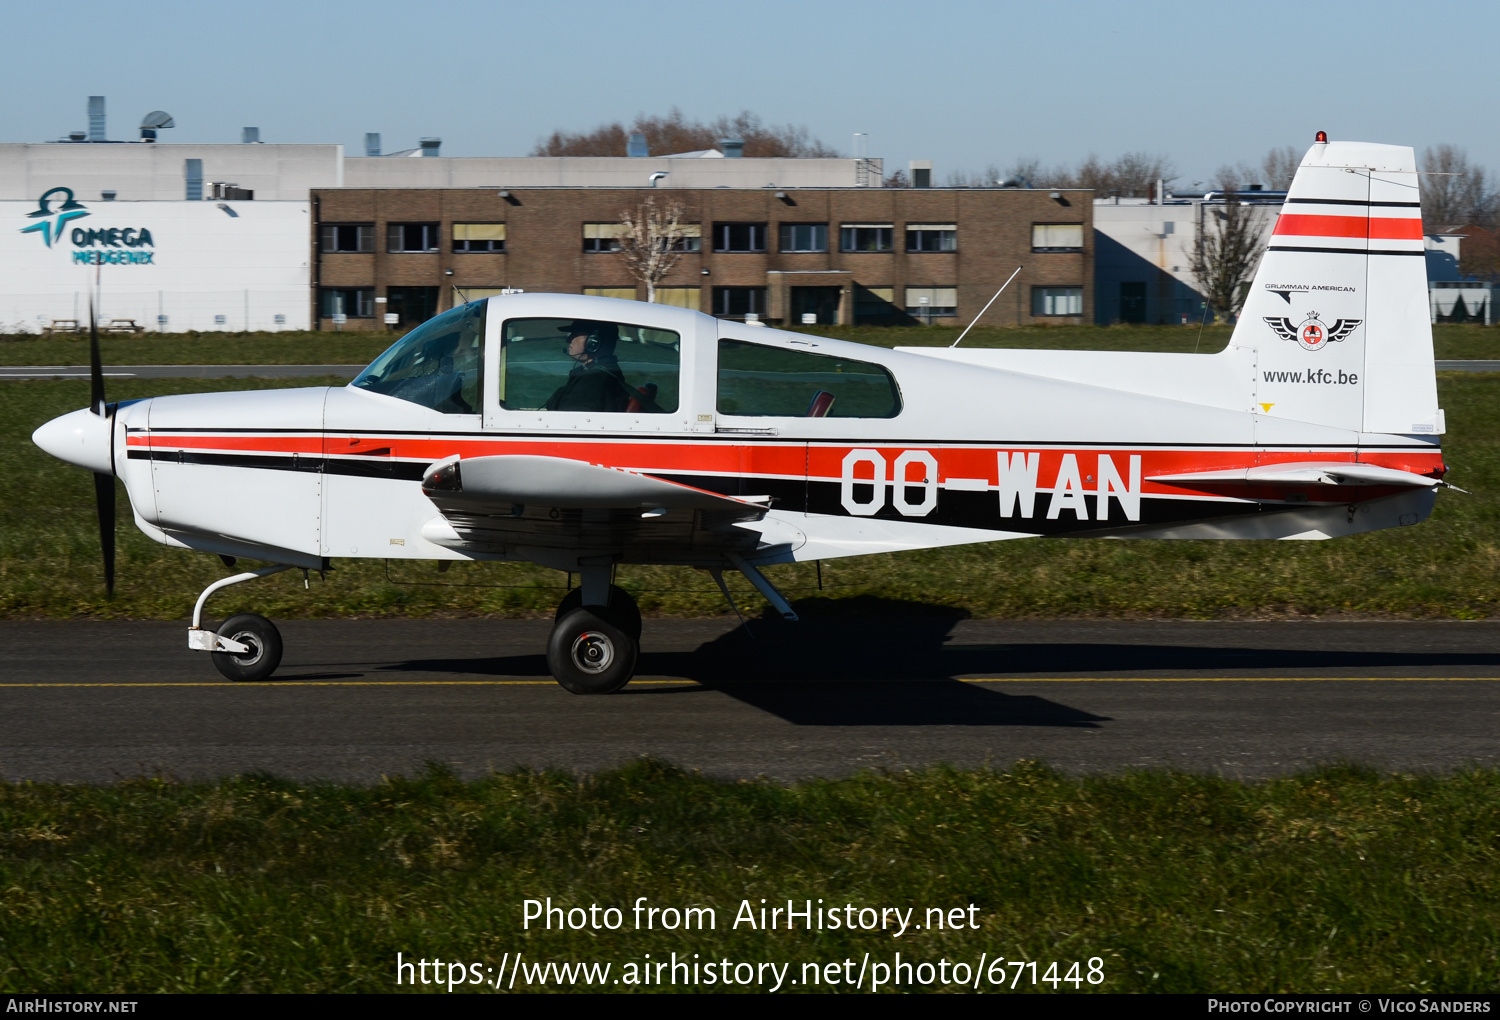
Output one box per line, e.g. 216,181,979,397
350,300,489,414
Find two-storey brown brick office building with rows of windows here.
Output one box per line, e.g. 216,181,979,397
312,188,1094,329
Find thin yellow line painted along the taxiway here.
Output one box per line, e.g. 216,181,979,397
0,677,1500,689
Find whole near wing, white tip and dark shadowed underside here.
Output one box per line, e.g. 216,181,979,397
422,455,768,563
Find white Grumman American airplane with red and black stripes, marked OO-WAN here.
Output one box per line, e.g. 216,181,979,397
33,134,1446,693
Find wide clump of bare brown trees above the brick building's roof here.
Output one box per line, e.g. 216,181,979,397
531,107,839,159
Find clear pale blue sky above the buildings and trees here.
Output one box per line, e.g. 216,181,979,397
0,0,1500,185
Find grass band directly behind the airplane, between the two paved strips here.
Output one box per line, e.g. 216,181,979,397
0,374,1500,620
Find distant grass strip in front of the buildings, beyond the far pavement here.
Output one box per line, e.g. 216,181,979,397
0,326,1500,365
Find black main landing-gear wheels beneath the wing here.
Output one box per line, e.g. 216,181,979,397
548,585,641,695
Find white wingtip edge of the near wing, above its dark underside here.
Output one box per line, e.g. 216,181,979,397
422,455,765,521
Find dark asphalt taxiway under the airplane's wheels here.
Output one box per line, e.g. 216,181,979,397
0,618,1500,782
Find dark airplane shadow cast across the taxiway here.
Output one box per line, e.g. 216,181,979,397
363,599,1500,729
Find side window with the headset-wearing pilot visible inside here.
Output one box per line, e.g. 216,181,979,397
498,318,683,414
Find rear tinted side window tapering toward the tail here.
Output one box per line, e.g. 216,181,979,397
719,339,902,419
